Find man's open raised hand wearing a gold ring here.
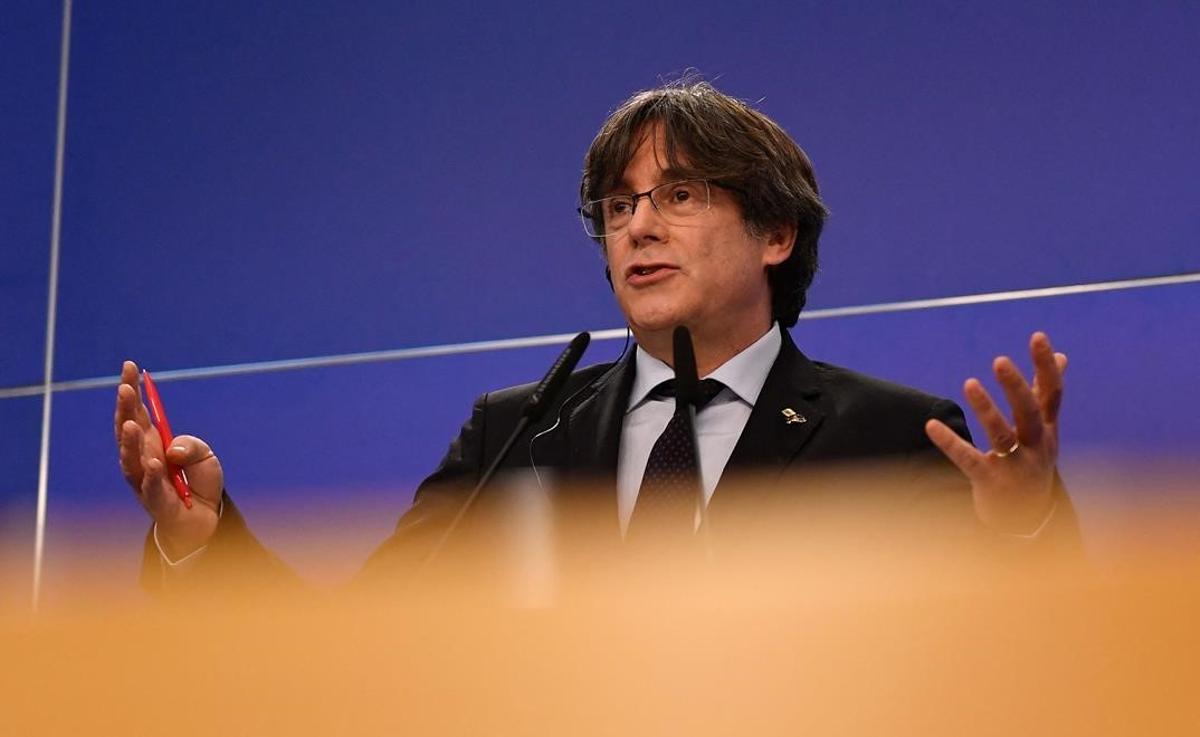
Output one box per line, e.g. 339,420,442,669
925,332,1067,534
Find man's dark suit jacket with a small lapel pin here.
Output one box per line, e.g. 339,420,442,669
144,330,1078,595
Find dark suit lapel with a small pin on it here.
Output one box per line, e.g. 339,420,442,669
714,328,824,484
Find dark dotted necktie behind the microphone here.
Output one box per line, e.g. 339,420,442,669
628,379,725,537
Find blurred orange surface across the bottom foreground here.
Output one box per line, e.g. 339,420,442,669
0,470,1200,737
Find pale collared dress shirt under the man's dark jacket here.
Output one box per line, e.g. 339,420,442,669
617,323,784,534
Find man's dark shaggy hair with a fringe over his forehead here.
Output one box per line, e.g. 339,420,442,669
580,78,829,328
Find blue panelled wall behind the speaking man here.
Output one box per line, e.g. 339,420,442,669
0,0,1200,598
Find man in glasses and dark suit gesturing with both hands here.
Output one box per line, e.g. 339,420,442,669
115,82,1074,585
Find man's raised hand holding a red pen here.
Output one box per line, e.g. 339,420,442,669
113,361,224,561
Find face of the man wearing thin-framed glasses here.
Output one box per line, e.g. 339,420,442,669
605,128,792,347
